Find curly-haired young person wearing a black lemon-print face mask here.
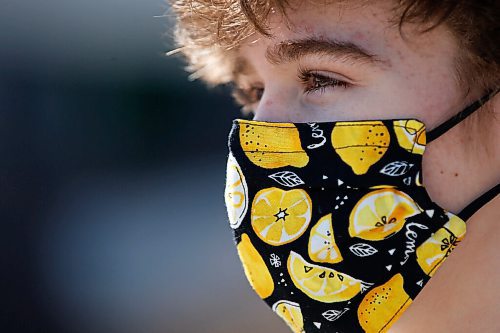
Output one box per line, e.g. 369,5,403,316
173,0,500,332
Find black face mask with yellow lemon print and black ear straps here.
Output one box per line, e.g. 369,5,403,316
225,94,500,333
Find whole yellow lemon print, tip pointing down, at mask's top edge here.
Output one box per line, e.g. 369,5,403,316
331,121,390,175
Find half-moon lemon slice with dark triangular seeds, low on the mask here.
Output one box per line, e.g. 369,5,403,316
287,251,370,303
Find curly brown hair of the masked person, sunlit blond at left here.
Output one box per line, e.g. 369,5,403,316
170,0,500,90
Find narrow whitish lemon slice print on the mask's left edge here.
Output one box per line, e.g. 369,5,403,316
224,154,248,229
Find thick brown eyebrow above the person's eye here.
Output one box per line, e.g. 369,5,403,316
266,38,388,65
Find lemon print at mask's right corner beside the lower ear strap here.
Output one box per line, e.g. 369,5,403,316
416,213,466,276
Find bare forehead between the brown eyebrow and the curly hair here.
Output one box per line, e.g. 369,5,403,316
234,1,456,72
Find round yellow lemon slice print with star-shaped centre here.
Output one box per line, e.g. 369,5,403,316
251,187,312,246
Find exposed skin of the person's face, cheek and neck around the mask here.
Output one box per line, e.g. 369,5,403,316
231,1,500,332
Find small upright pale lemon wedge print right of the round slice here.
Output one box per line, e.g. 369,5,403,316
308,214,343,264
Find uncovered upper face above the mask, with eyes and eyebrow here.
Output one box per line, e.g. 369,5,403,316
235,1,464,128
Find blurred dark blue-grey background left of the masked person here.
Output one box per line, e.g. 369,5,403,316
0,0,289,333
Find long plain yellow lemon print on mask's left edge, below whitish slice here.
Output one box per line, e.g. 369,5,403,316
236,234,274,299
